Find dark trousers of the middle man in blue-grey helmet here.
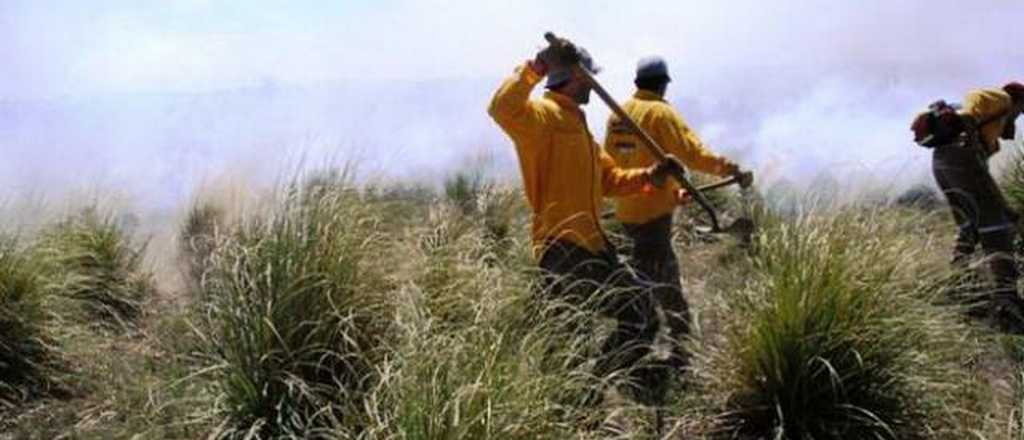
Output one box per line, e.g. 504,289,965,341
623,214,690,366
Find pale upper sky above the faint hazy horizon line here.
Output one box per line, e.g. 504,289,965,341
0,0,1024,97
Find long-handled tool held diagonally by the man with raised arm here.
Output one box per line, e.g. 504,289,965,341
544,32,753,238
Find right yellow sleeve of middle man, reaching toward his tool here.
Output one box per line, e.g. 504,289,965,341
654,106,736,176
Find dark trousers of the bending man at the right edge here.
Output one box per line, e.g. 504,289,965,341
932,145,1020,304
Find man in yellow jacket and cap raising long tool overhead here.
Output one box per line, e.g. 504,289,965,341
488,42,682,401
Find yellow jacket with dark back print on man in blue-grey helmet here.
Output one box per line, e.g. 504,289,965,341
604,90,736,224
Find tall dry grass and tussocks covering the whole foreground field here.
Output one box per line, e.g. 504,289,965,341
8,166,1019,440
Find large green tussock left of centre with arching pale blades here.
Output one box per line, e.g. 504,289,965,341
197,178,390,438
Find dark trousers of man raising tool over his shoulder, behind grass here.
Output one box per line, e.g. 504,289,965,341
540,241,658,394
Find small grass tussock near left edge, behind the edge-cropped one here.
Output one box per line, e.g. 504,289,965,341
40,208,155,327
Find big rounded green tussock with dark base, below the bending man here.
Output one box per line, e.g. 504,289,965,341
709,207,983,439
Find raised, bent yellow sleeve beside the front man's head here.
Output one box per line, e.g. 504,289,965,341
487,63,545,152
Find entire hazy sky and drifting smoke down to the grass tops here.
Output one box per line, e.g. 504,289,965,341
0,0,1024,206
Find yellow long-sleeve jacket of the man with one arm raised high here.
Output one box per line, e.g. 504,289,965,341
487,63,651,258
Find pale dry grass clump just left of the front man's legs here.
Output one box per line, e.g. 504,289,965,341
371,208,603,440
